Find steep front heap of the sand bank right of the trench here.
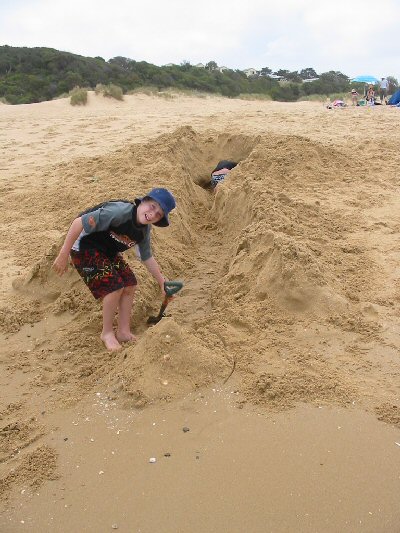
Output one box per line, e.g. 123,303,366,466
212,224,346,316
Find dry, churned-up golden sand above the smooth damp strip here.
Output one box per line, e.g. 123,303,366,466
0,91,400,520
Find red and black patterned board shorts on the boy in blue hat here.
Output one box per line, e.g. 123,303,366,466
70,250,137,300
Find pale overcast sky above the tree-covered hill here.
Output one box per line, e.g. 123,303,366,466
0,0,400,81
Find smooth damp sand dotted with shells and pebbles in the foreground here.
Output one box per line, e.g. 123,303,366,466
3,388,400,533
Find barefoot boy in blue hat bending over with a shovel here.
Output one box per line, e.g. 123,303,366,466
53,188,176,351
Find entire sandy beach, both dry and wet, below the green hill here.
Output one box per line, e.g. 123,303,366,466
0,94,400,533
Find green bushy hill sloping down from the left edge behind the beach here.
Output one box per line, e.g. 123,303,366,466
0,45,279,104
